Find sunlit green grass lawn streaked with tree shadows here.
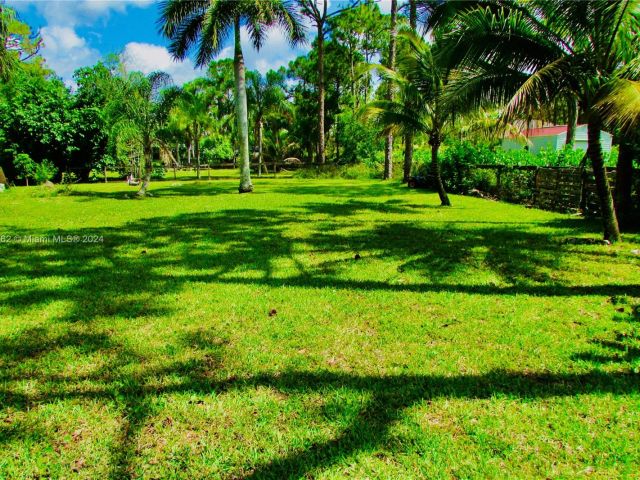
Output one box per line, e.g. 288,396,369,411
0,178,640,479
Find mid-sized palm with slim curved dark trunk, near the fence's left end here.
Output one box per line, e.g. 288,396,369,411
363,31,455,206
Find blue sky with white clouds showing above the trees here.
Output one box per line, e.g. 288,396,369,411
6,0,390,84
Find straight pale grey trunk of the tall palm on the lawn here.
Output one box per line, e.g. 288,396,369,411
233,17,253,193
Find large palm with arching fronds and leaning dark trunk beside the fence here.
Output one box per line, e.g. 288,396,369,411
424,0,640,242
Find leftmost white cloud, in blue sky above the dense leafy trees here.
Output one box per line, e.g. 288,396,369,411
41,26,100,83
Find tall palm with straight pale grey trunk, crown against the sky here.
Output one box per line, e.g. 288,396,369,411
160,0,304,193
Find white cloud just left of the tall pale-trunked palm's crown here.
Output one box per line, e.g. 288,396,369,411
122,42,201,85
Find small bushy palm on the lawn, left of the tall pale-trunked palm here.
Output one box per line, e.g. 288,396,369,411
107,72,179,197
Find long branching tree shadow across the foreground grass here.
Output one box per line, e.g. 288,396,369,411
0,322,640,479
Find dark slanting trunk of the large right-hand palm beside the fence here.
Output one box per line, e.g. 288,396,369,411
587,115,620,242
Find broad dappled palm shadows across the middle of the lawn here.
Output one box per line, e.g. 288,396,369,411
0,200,640,321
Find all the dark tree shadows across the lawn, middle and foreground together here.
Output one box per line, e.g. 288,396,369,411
0,185,640,478
